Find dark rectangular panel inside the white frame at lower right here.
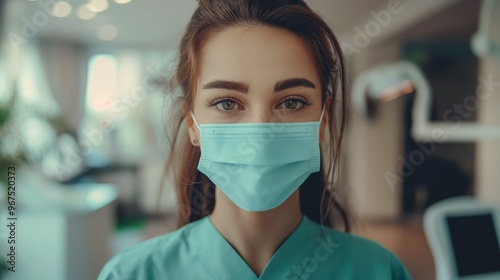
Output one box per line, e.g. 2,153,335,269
446,214,500,276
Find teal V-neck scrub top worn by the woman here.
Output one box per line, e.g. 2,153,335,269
98,216,411,280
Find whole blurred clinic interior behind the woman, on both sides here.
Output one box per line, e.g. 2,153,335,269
0,0,500,280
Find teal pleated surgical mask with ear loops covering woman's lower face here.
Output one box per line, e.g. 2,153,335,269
190,106,325,212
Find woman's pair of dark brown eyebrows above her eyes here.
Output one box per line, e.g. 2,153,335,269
203,78,316,93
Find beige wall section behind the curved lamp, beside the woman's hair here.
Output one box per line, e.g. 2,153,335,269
346,40,404,219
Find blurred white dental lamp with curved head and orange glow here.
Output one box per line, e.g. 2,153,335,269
352,61,500,142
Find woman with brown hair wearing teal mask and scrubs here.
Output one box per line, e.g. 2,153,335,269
99,0,410,280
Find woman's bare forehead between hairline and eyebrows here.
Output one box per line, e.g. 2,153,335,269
199,26,319,87
